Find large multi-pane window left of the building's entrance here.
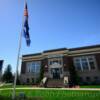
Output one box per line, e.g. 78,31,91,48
27,61,41,73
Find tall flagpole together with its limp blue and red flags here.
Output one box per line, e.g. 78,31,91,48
12,1,31,100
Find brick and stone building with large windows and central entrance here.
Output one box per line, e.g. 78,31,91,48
21,45,100,87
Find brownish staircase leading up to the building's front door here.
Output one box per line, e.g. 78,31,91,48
47,79,64,88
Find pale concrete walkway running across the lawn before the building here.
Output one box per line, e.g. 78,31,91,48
0,87,100,91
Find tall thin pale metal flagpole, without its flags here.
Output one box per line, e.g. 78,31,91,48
12,0,26,100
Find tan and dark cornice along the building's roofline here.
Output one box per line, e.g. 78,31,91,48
22,45,100,61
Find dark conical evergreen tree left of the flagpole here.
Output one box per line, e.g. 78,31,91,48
3,64,13,83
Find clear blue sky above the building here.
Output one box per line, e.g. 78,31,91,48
0,0,100,72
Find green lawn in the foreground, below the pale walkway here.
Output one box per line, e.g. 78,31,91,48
0,89,100,100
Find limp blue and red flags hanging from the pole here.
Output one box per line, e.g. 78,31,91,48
23,3,31,46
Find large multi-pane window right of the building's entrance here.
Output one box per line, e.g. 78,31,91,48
74,56,96,71
